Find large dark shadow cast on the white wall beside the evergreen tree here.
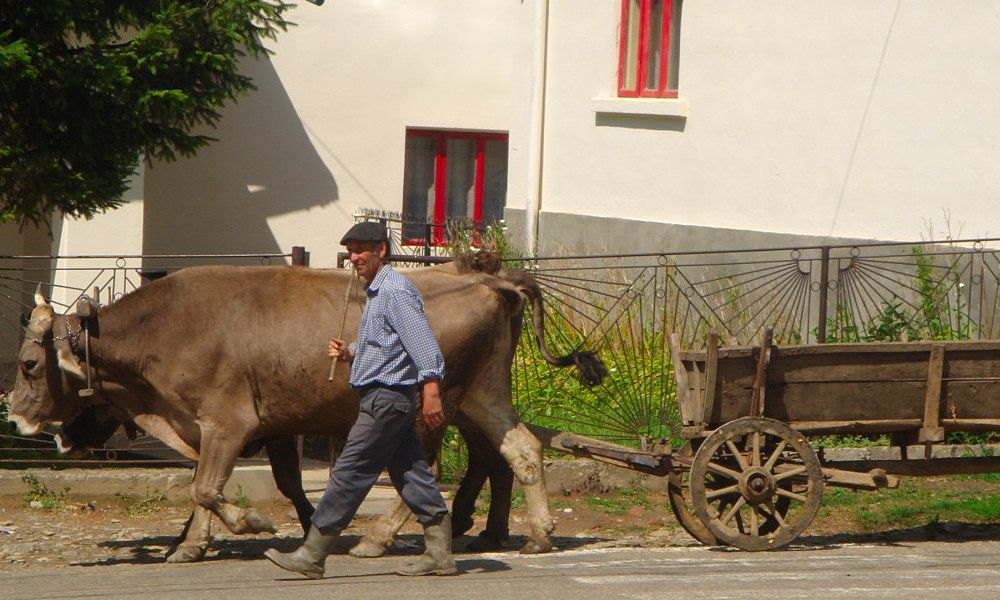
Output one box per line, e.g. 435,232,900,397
143,60,339,254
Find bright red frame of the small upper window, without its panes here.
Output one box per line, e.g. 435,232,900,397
618,0,677,98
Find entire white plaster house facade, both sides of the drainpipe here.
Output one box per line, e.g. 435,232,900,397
0,0,1000,266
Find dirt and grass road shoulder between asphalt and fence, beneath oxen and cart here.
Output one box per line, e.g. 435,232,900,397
0,478,1000,571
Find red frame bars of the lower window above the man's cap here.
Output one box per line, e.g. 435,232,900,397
403,129,510,246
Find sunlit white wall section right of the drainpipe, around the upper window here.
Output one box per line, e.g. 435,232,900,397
542,0,1000,244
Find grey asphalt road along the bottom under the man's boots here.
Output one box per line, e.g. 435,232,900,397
7,541,1000,600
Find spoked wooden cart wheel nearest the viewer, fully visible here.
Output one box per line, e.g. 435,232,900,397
690,417,823,551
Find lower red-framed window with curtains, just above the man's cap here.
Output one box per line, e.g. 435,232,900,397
403,129,507,245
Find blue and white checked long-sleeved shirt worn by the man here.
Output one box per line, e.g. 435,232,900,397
350,265,444,387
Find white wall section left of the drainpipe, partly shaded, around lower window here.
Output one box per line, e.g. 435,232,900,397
145,0,532,266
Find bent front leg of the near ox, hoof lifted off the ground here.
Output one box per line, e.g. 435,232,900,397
191,424,276,534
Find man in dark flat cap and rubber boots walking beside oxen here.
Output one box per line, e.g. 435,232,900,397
264,222,457,579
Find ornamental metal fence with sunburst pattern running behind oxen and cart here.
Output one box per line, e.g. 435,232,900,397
0,232,1000,458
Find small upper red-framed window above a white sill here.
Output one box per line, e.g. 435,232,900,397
618,0,683,98
